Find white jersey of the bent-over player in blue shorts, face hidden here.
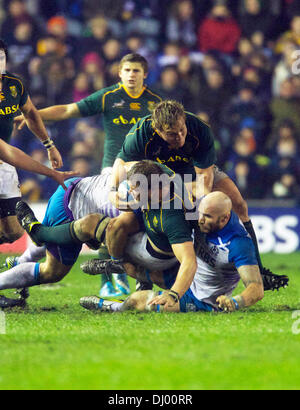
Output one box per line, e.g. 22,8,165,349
68,169,120,220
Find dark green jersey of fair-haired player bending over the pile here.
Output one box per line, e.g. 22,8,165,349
118,112,216,179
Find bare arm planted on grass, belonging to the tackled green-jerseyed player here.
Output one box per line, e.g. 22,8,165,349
149,242,197,310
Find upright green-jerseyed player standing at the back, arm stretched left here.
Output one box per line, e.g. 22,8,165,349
15,54,161,296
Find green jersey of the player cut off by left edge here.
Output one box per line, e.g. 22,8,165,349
0,72,28,142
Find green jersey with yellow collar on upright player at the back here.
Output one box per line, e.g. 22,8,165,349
77,82,161,168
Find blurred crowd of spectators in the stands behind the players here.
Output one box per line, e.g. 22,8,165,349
0,0,300,201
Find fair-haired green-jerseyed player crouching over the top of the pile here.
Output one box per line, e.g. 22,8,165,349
109,100,282,284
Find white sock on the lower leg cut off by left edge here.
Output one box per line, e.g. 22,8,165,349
0,262,40,289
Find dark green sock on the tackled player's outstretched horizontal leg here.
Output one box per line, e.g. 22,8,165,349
30,222,82,245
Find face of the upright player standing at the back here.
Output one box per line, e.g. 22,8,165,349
119,62,147,92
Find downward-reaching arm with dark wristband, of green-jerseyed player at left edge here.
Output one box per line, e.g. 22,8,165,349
20,96,63,168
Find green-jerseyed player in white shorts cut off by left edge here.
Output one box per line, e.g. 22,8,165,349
0,40,63,244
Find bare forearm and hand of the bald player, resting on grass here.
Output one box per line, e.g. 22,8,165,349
217,265,264,312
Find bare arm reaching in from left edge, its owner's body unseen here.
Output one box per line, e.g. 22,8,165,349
0,139,76,189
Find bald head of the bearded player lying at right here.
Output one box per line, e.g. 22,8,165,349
199,191,232,233
